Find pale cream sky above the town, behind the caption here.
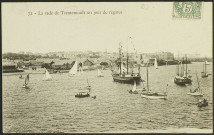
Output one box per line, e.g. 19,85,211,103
2,2,213,57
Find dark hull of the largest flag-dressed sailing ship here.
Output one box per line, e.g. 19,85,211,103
113,76,142,84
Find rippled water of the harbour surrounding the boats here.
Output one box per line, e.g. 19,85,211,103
2,63,213,133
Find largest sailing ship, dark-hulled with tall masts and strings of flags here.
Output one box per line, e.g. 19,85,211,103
112,40,143,84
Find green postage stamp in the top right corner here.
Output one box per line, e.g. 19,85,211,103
173,1,202,19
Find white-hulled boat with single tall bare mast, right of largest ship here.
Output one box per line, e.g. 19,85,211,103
141,66,168,99
